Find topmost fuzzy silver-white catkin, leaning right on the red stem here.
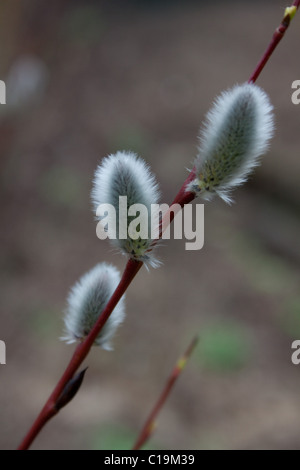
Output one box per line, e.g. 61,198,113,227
187,83,274,202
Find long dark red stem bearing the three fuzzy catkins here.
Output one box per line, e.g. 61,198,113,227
18,4,300,450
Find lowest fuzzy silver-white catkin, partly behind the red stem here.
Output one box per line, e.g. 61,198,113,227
61,263,125,350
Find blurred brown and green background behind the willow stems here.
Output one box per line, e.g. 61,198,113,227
0,0,300,449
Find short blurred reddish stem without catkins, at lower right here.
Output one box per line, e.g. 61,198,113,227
132,337,198,450
